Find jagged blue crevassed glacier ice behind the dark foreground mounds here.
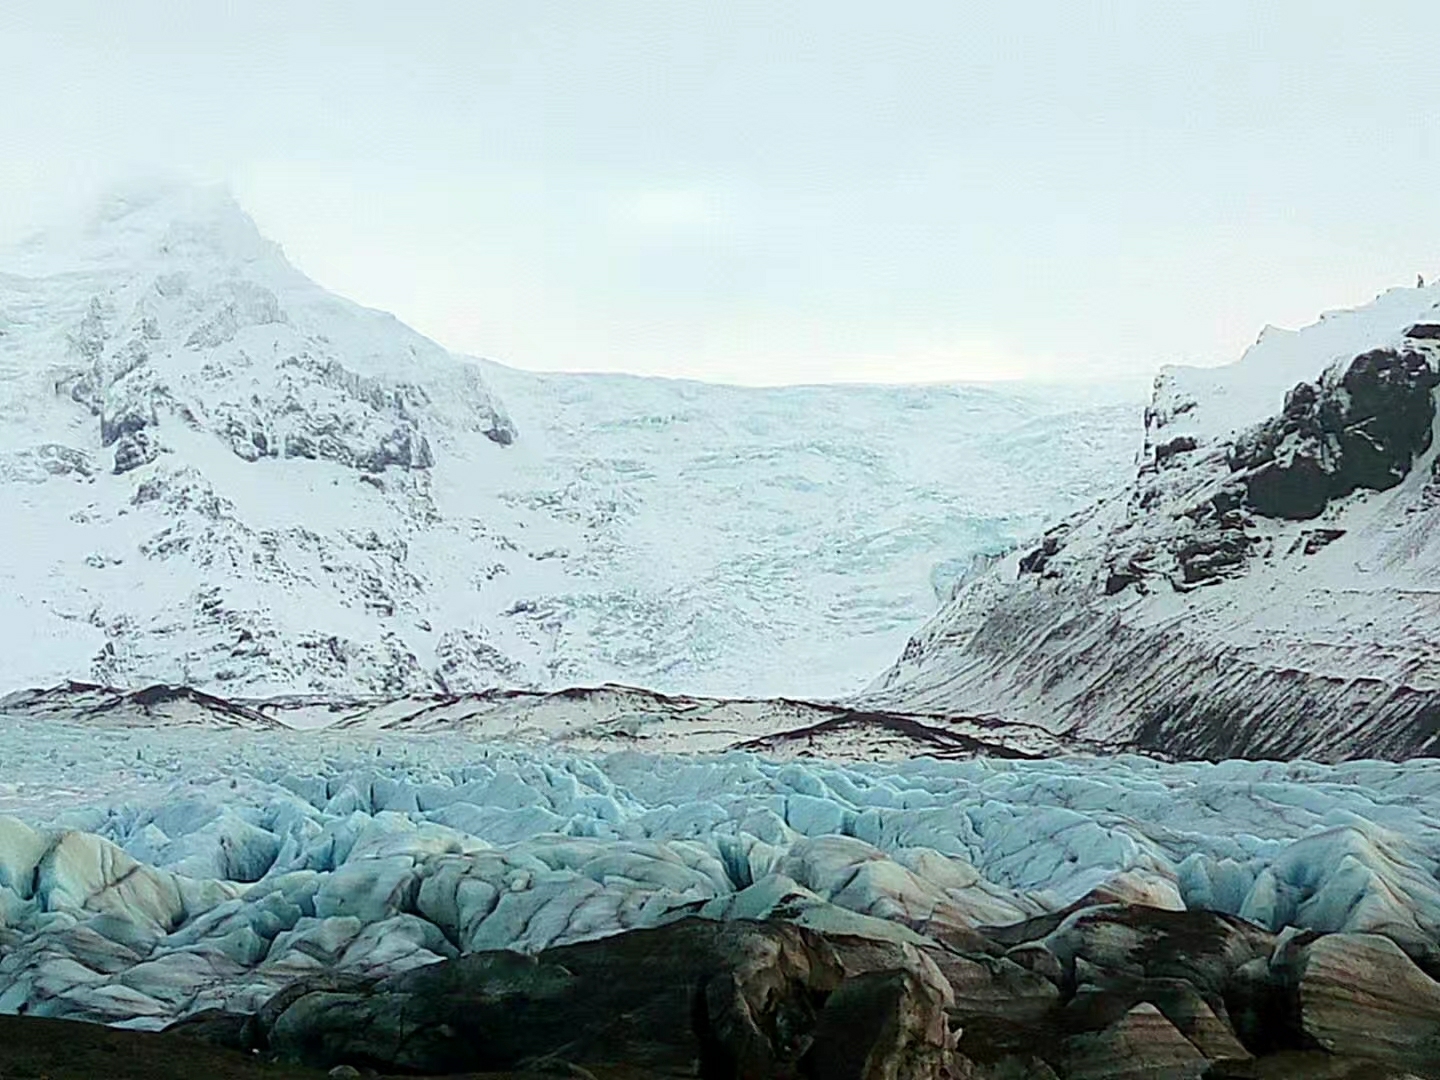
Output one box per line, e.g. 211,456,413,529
0,717,1440,1027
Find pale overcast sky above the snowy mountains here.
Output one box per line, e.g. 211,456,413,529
0,0,1440,383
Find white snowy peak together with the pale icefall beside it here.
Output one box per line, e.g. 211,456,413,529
0,187,1139,696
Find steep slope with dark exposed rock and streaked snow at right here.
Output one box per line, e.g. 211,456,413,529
868,287,1440,759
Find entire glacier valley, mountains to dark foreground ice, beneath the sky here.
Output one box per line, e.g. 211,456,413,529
8,190,1440,1080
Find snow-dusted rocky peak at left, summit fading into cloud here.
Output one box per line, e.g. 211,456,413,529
0,182,514,688
